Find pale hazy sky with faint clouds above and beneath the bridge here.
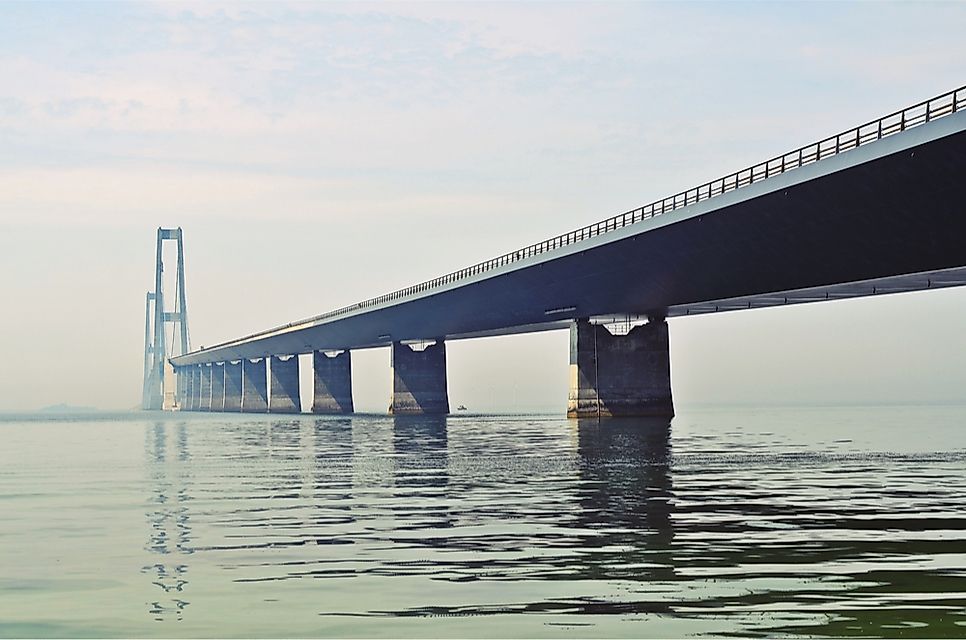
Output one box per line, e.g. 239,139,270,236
0,1,966,411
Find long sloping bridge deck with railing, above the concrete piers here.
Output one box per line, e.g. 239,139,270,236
172,89,966,366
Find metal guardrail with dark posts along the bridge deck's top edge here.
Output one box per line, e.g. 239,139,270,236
195,86,966,350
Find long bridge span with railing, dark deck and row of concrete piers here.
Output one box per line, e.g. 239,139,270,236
158,87,966,417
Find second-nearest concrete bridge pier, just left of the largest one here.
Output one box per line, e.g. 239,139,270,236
389,340,449,415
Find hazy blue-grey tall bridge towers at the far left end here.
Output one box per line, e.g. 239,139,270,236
141,227,190,410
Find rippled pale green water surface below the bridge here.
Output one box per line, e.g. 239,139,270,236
0,407,966,637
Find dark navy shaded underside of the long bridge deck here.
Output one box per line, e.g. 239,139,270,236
175,121,966,366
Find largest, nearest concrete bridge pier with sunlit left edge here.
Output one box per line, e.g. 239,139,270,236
567,317,674,418
